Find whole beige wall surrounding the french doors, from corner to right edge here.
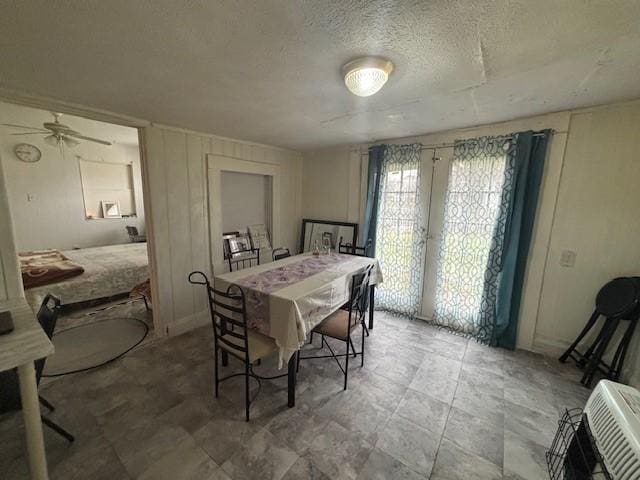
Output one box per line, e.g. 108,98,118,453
302,101,640,382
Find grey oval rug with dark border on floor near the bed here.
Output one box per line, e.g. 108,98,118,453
42,318,149,377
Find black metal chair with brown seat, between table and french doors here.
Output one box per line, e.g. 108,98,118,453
298,265,373,390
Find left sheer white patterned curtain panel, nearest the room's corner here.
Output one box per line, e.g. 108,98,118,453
375,144,425,316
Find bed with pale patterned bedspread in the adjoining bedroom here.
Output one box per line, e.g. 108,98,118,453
21,243,149,310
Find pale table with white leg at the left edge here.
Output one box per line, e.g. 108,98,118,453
0,298,53,480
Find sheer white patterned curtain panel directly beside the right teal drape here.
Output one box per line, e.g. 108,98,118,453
433,136,513,343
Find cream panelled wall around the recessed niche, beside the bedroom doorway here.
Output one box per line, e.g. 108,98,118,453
143,126,302,334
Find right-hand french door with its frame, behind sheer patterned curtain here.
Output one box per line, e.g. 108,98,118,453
421,141,507,334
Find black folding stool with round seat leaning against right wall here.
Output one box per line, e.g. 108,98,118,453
559,277,640,387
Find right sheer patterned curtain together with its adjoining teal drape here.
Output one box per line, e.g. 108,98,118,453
434,130,551,348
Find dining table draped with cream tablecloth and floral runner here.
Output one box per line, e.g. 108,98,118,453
214,252,382,407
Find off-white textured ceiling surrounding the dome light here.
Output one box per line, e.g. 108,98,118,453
0,0,640,150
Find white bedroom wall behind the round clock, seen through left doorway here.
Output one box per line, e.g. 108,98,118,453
0,103,144,251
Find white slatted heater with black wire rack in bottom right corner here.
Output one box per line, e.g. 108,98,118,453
546,380,640,480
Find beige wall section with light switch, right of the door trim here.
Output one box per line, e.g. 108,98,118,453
535,101,640,385
